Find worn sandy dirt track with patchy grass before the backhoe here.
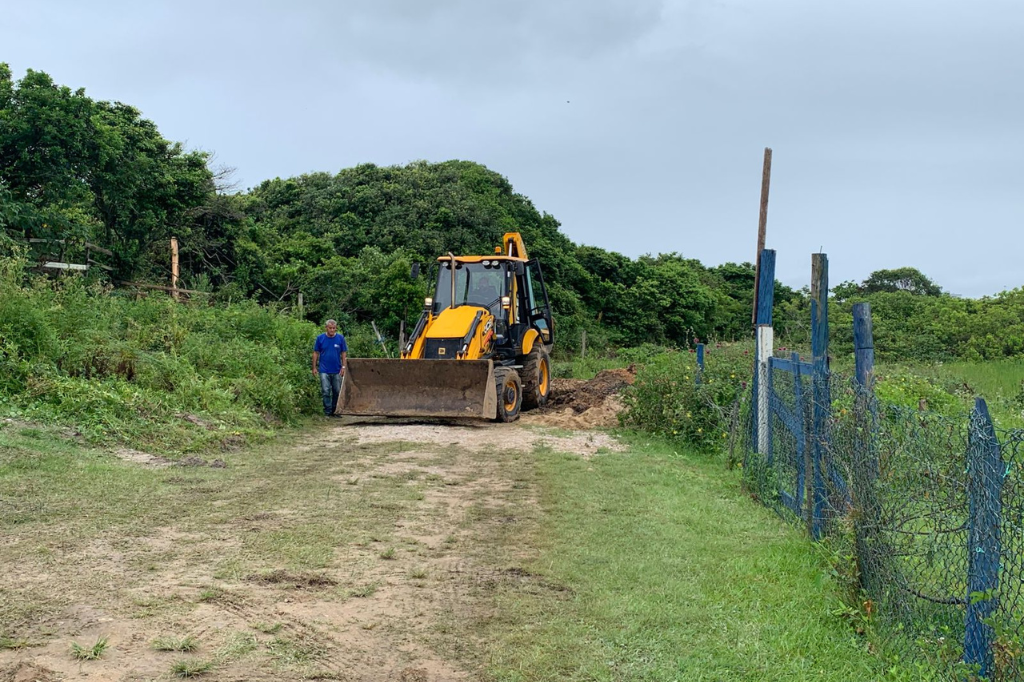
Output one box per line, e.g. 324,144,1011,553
0,419,617,682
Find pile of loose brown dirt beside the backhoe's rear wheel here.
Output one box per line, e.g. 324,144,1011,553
522,365,636,429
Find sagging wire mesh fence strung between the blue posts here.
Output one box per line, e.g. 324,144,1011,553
734,360,1024,681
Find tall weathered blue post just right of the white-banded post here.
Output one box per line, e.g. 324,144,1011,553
811,253,831,540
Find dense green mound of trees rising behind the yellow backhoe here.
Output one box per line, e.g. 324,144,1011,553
207,161,797,349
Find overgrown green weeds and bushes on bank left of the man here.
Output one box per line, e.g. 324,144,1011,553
0,258,318,450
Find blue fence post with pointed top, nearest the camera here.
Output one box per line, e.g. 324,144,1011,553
964,398,1002,678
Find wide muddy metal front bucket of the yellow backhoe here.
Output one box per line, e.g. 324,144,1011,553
337,358,498,419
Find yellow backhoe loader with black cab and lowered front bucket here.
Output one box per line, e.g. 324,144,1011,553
338,232,555,422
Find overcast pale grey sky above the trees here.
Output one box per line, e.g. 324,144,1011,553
0,0,1024,297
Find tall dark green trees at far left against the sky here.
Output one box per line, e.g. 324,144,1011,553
0,63,214,279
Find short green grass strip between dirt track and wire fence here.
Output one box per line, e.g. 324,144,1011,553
487,432,881,682
